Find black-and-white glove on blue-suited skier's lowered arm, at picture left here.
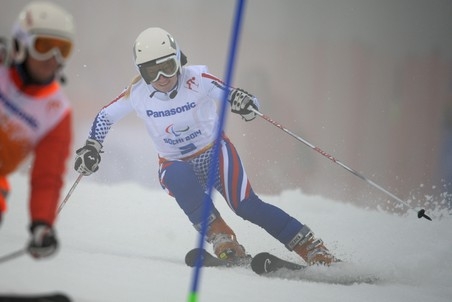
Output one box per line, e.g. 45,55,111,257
74,138,102,176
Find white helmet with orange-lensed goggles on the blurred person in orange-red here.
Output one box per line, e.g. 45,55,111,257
13,2,75,63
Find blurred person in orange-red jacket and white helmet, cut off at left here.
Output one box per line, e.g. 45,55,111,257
0,2,74,258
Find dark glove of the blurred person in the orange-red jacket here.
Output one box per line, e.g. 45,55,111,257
27,222,58,259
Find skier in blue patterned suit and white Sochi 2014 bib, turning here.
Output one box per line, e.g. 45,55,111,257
75,27,337,265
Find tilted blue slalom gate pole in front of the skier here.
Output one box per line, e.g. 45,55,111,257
188,0,245,302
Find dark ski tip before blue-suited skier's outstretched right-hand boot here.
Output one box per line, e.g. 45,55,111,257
251,253,307,275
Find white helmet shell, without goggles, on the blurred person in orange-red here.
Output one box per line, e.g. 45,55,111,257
12,1,75,63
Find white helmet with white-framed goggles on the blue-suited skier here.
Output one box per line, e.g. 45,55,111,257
133,27,186,84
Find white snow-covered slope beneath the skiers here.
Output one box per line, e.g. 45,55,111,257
0,174,452,302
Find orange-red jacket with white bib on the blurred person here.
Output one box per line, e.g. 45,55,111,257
0,67,72,225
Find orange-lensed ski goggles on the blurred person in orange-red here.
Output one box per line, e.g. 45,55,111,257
28,36,72,61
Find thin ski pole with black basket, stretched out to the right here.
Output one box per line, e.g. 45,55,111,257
248,106,432,221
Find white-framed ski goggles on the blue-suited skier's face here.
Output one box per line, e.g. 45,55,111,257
138,55,179,84
